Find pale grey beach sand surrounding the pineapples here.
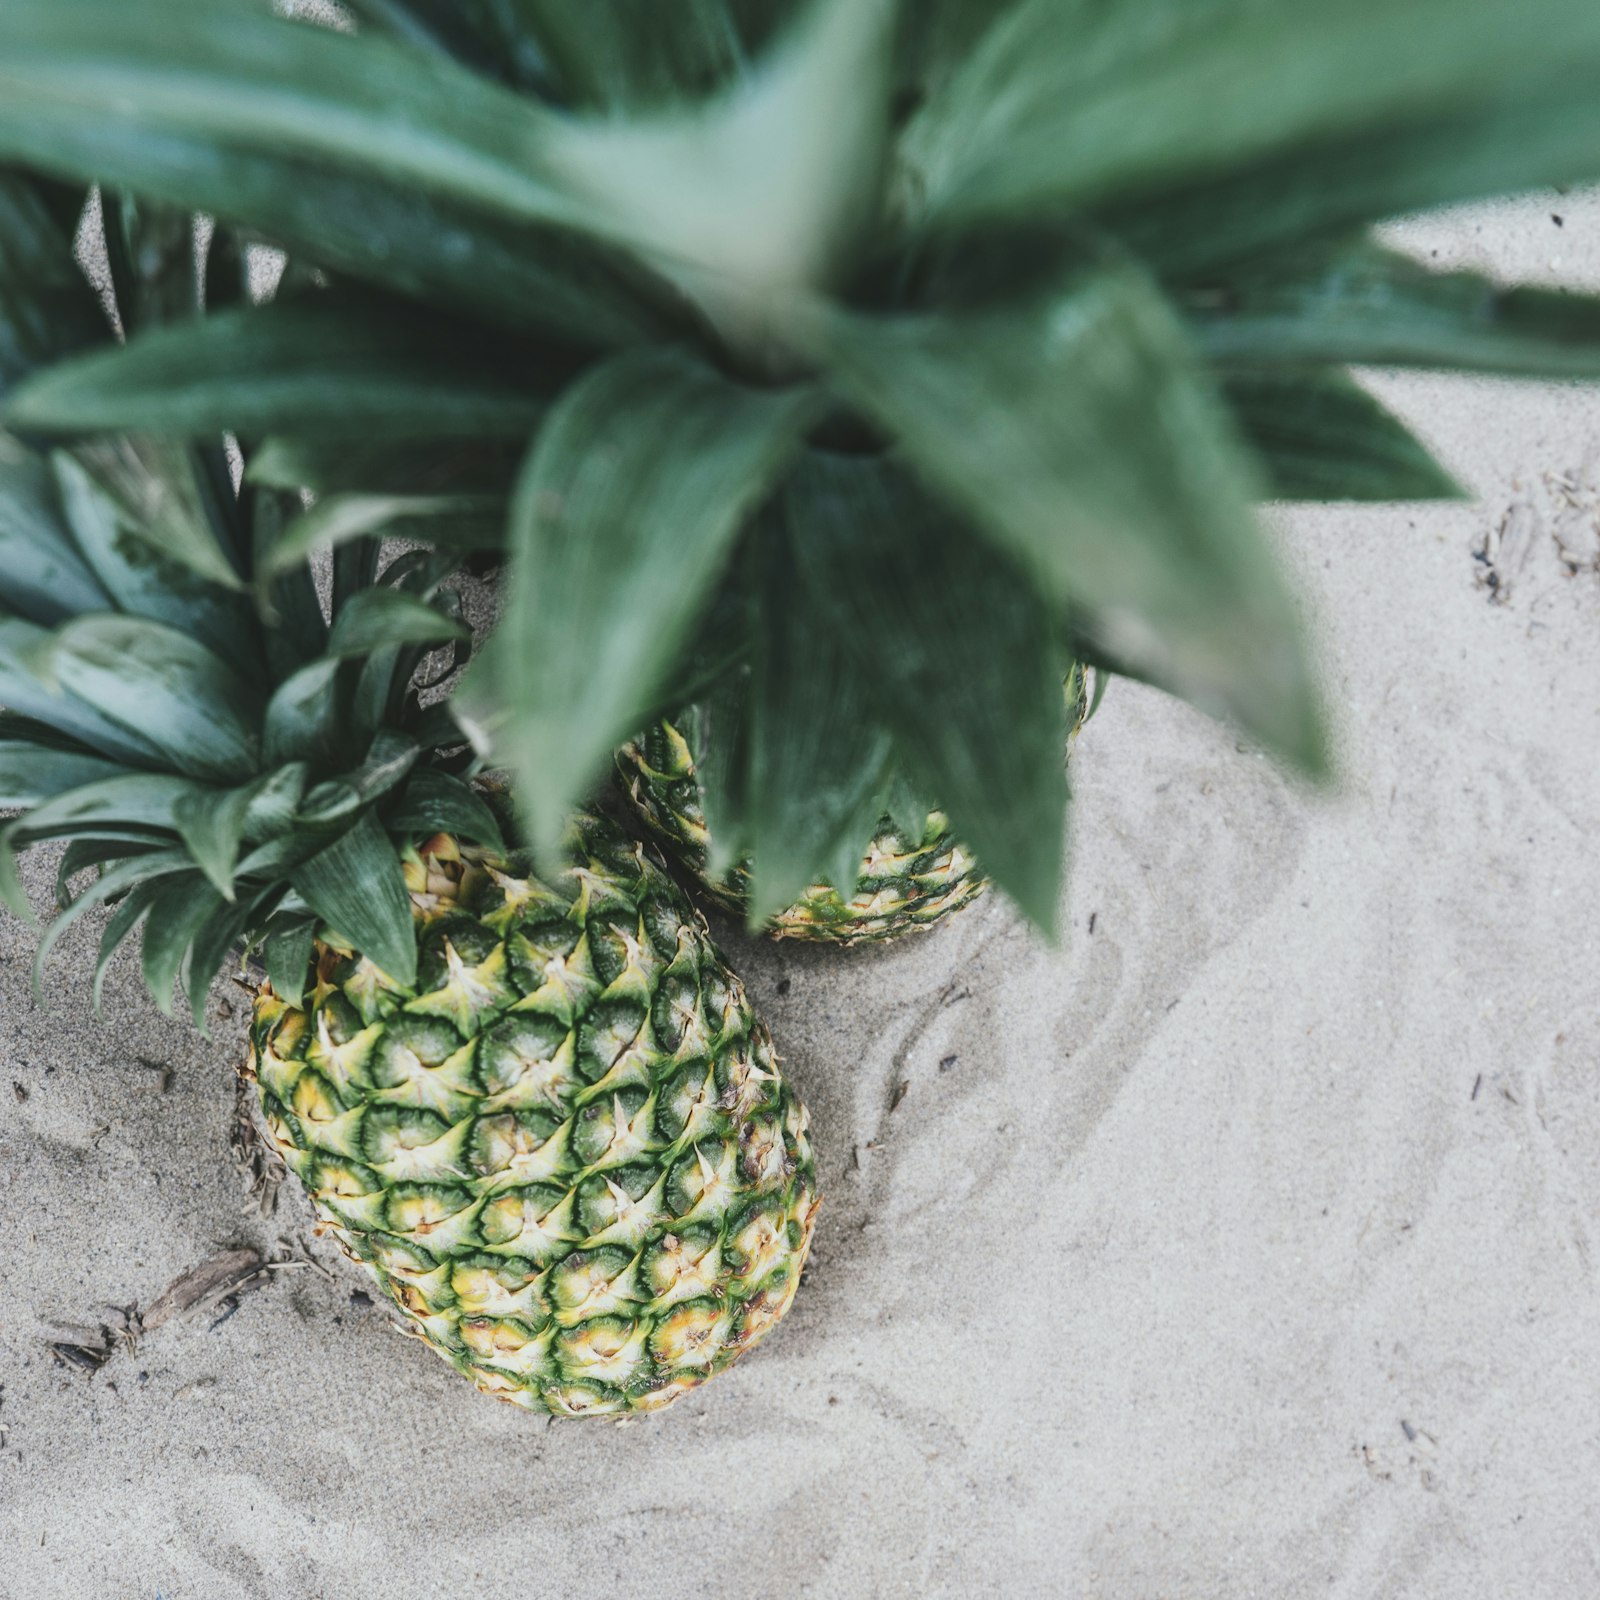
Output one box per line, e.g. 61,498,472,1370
0,197,1600,1600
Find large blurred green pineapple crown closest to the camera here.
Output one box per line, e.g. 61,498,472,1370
0,0,1600,925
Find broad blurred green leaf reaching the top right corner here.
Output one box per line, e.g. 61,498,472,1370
915,0,1600,236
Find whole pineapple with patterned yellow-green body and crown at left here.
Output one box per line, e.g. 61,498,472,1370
0,173,818,1416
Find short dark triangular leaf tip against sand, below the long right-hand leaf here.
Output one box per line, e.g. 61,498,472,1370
1222,368,1472,502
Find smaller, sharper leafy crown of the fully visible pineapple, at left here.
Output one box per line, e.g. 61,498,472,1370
0,174,499,1021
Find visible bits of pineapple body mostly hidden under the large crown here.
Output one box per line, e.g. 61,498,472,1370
616,669,1090,946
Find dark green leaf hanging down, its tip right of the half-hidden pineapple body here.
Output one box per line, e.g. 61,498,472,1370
786,454,1067,933
